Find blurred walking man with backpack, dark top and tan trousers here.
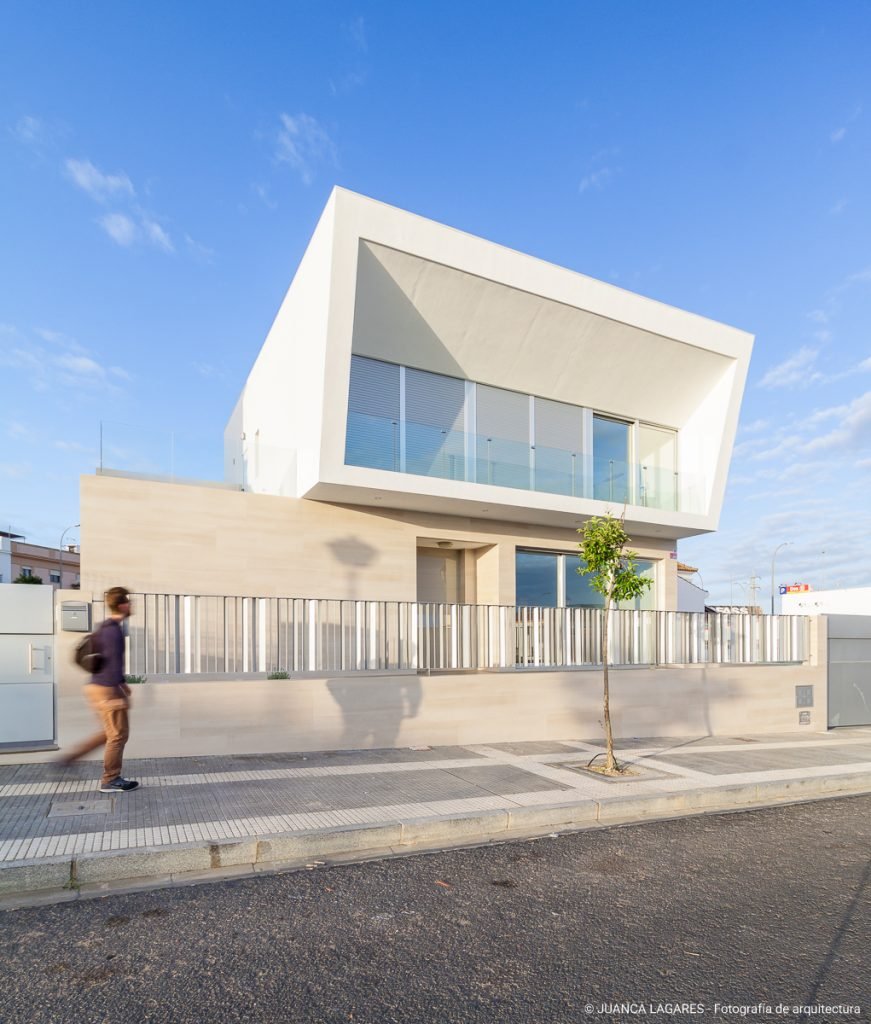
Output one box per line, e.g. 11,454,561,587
61,587,139,793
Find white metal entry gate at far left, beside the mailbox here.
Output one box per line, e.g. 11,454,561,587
0,583,55,752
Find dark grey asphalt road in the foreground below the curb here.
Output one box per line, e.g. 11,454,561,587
0,797,871,1024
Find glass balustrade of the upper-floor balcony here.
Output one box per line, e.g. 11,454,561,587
345,411,703,513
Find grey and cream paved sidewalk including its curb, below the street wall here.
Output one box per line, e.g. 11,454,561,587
0,729,871,909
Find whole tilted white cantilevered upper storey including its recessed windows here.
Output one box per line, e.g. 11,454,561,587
225,188,752,538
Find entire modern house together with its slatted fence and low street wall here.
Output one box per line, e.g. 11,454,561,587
8,188,826,756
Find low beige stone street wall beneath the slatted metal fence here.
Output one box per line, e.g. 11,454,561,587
0,662,826,764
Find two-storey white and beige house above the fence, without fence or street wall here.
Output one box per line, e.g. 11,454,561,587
82,188,752,609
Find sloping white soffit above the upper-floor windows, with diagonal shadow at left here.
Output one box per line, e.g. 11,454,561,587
352,240,741,428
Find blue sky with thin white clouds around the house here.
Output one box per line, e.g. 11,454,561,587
0,0,871,602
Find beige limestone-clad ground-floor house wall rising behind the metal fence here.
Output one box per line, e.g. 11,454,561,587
81,474,678,608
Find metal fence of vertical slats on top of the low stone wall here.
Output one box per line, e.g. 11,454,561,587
95,594,810,675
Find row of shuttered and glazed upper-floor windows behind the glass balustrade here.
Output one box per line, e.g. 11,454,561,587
345,355,682,511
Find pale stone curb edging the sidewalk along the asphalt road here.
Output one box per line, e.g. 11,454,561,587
0,772,871,910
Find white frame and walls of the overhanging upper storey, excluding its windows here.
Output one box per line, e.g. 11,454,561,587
225,188,752,540
